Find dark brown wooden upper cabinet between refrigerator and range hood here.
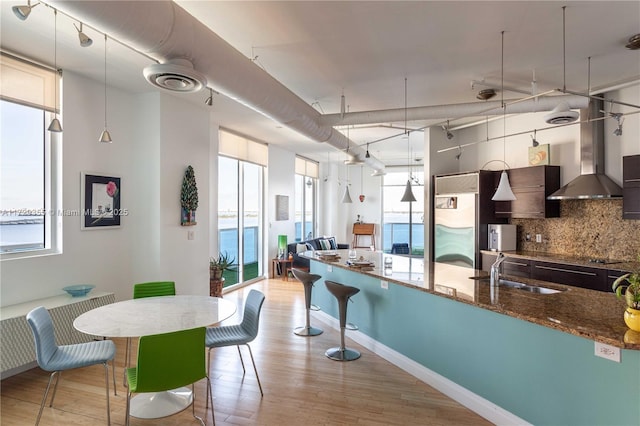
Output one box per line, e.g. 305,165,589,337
495,166,560,219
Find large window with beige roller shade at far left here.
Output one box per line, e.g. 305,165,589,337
0,53,62,260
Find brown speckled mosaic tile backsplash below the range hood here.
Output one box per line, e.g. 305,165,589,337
511,200,640,261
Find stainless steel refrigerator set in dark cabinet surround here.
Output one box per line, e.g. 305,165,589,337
432,171,504,269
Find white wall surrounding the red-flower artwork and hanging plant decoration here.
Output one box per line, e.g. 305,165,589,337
0,71,215,306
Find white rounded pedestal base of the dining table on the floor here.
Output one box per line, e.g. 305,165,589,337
130,387,193,419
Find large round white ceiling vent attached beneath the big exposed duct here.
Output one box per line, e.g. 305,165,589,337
143,59,207,93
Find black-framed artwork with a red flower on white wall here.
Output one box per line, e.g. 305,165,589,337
80,173,126,229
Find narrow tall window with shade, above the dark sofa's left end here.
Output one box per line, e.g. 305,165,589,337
295,157,318,241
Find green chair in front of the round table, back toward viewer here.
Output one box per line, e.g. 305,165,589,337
125,327,216,426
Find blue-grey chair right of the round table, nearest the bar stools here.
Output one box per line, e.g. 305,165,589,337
205,290,264,396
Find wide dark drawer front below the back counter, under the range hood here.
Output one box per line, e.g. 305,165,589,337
531,260,611,291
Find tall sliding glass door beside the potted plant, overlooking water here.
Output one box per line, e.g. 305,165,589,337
218,156,264,287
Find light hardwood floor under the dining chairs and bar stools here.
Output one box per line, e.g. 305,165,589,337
0,279,490,426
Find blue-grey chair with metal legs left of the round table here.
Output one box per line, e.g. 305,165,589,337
27,306,116,425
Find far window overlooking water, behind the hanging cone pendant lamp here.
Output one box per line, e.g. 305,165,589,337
382,172,424,256
